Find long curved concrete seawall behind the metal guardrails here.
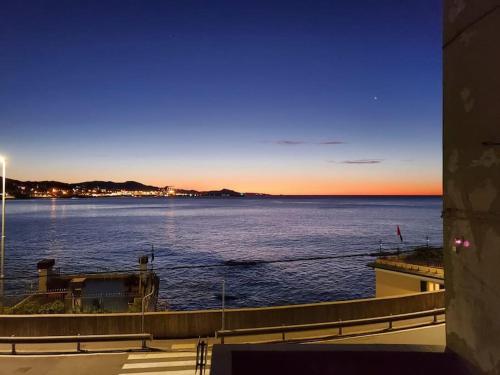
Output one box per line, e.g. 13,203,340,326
0,291,444,338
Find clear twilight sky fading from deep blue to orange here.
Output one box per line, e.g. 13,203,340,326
0,0,442,194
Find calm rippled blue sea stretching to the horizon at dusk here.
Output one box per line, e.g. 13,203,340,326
6,197,442,310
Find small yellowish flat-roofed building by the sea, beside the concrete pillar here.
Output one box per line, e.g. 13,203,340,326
369,247,444,297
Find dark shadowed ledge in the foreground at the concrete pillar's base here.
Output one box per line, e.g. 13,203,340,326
211,344,473,375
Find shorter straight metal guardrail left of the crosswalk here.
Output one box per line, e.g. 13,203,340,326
0,333,153,354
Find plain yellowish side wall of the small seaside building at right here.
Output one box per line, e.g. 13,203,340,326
375,269,420,298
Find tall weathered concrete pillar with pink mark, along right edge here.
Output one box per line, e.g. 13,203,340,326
443,0,500,374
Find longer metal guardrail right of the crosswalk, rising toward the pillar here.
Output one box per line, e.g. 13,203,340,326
215,308,445,344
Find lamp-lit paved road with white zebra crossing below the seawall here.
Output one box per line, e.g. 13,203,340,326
0,324,445,375
